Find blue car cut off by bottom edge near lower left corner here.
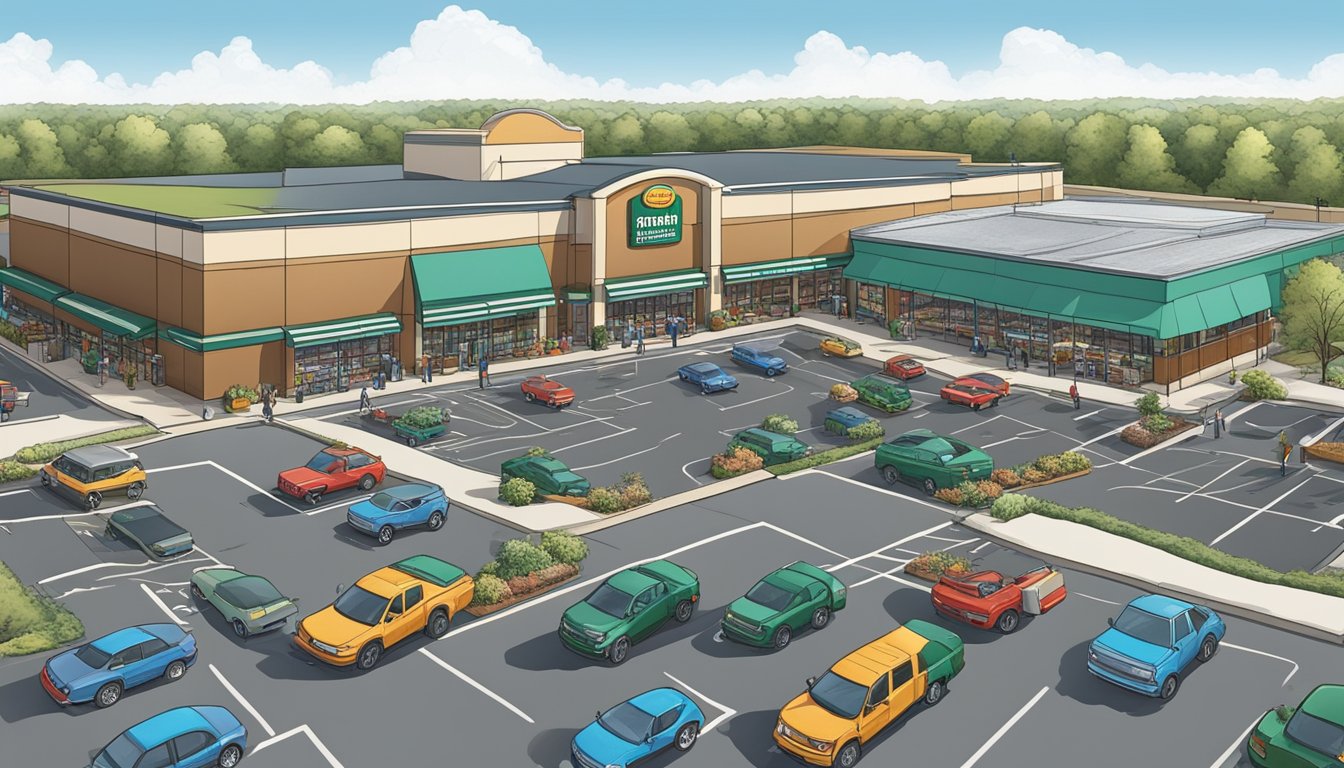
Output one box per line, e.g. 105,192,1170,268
91,706,247,768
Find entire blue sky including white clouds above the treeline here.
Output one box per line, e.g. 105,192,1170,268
0,0,1344,104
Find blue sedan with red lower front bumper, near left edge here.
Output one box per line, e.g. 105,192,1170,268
39,624,196,707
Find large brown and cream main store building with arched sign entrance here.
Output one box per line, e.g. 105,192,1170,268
0,109,1063,398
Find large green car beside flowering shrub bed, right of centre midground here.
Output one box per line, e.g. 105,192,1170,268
874,429,995,496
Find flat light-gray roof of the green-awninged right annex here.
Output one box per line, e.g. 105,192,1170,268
849,198,1344,278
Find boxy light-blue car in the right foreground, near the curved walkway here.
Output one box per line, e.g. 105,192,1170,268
1087,594,1227,699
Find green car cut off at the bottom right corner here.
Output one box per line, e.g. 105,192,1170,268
1246,685,1344,768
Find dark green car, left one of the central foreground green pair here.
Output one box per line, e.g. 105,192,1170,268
559,560,700,664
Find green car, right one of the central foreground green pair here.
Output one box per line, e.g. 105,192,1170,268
719,561,845,648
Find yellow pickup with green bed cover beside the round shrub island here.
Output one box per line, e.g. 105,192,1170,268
294,554,476,670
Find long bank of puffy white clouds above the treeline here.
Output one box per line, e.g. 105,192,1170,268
0,5,1344,104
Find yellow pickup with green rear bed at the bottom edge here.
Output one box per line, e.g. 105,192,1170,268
774,620,966,768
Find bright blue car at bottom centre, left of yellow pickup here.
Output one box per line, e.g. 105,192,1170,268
570,689,704,768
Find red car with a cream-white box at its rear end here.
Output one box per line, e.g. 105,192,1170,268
931,551,1068,635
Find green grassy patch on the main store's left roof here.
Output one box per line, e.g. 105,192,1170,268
38,184,280,219
